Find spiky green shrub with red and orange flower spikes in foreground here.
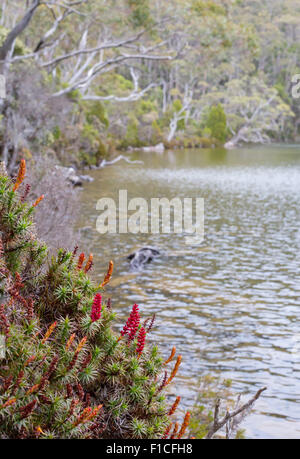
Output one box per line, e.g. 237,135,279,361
0,160,190,439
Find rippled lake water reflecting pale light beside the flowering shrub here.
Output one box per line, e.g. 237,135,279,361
79,146,300,438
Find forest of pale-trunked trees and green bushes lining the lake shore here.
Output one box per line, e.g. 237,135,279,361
0,0,300,170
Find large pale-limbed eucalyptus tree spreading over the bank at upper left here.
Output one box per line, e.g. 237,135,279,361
0,0,175,169
